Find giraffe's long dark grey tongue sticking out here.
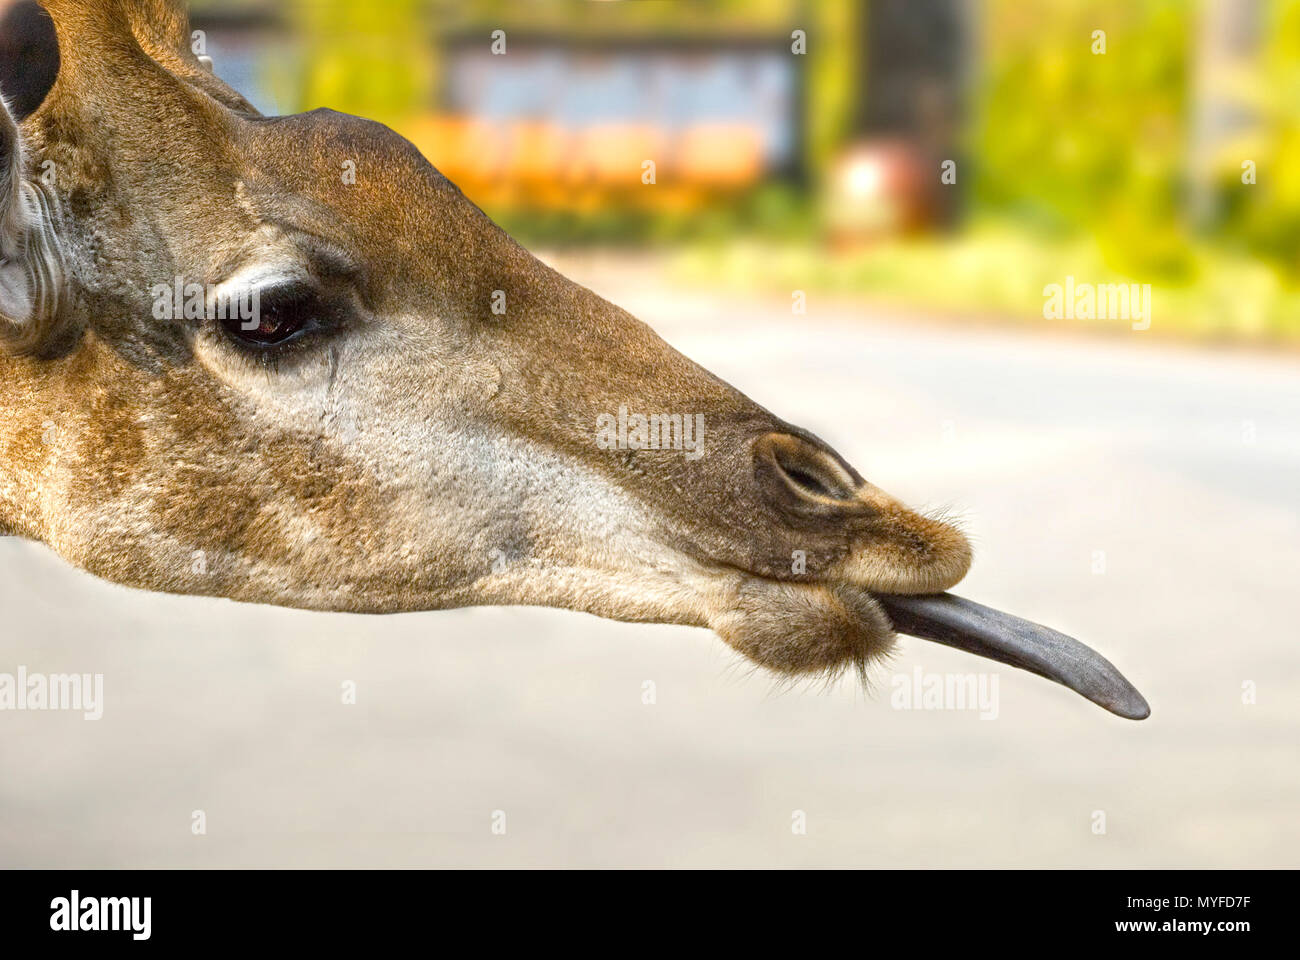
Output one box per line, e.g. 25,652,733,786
872,593,1151,719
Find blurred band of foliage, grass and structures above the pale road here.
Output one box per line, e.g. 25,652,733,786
172,0,1300,343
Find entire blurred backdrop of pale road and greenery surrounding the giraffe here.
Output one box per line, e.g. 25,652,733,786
0,0,1300,866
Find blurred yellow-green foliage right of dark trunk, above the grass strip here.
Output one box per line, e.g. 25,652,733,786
971,0,1300,295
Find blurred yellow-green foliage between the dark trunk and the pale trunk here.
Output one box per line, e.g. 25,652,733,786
971,0,1195,280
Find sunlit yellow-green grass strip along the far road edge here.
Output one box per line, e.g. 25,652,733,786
671,226,1300,343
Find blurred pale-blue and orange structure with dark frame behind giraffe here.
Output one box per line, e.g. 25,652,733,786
421,34,801,208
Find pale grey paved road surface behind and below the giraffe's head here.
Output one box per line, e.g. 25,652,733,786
0,264,1300,866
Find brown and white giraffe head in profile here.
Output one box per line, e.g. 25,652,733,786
0,0,1140,700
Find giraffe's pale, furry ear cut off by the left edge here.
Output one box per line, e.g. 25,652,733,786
0,99,60,353
